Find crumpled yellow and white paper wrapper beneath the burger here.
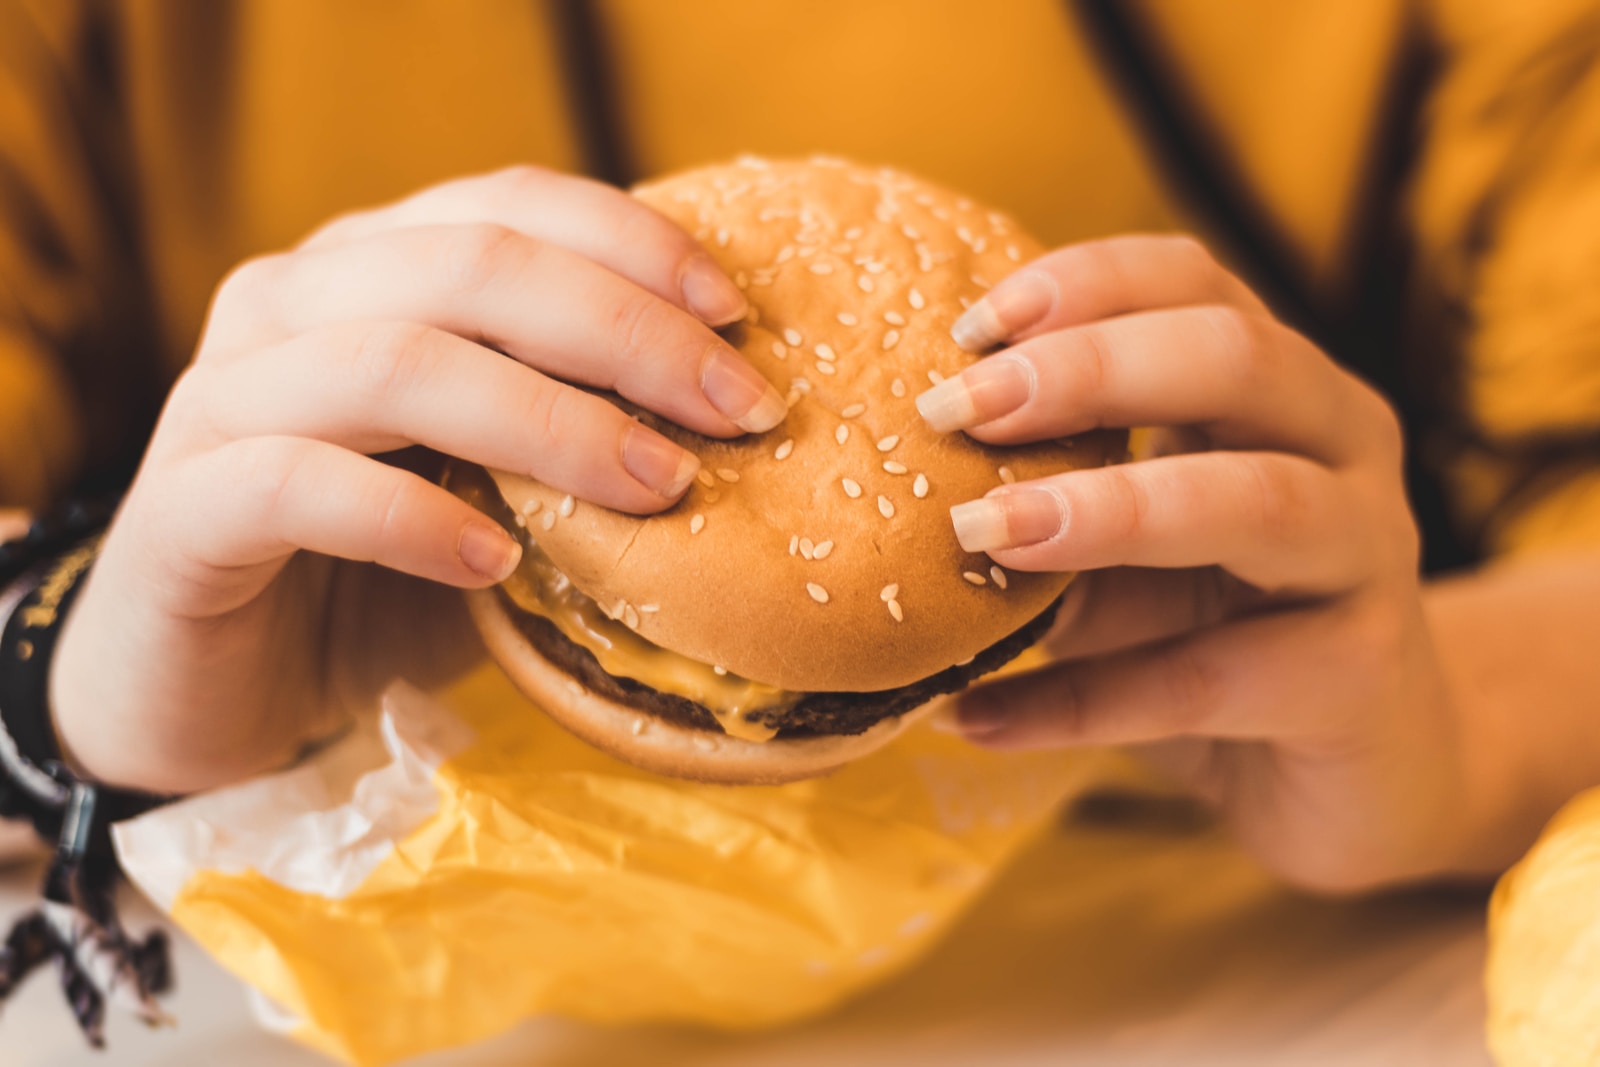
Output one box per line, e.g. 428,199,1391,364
117,667,1107,1064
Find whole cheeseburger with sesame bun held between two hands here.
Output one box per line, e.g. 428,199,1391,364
451,158,1126,782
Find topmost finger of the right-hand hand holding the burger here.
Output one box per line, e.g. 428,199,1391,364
950,234,1266,352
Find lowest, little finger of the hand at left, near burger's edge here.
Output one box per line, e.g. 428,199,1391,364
157,437,522,601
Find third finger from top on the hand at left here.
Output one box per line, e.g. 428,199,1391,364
186,323,699,512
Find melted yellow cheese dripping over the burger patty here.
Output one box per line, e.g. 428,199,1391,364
502,536,800,741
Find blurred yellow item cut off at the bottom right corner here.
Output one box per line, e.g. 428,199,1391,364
1488,789,1600,1067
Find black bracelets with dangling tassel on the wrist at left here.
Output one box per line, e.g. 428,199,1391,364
0,502,171,1048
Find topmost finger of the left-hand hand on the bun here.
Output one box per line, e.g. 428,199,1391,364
301,166,749,326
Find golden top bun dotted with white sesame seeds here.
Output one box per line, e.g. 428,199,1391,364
494,158,1126,691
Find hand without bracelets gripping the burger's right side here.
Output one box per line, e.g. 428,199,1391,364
918,237,1469,891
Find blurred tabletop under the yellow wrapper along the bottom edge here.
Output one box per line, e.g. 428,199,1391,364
0,796,1490,1067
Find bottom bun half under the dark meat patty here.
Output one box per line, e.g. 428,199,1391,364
467,589,933,785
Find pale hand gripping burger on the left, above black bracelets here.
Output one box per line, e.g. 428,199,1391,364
51,168,786,793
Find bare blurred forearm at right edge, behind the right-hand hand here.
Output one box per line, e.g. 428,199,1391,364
1418,552,1600,873
